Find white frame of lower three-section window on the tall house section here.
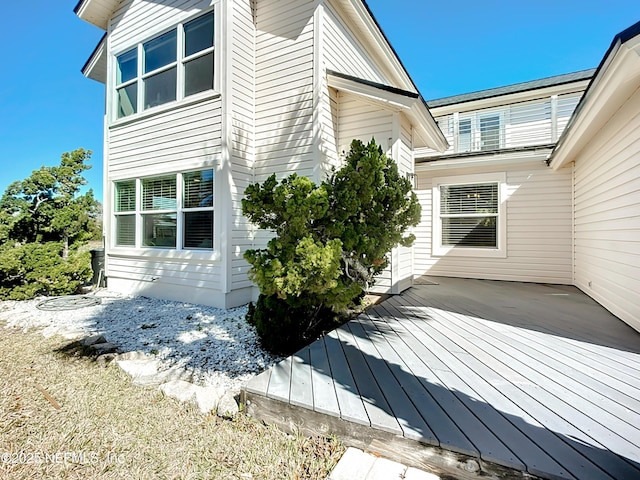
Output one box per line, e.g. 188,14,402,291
109,166,219,253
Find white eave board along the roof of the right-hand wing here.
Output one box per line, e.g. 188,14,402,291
549,36,640,170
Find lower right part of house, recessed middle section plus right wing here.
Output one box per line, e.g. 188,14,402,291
414,23,640,330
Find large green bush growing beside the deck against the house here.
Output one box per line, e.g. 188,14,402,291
242,140,420,352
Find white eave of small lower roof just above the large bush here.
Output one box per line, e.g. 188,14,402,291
327,73,449,152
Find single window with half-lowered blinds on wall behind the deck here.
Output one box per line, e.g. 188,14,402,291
440,182,499,248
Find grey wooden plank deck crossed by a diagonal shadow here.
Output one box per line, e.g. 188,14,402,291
243,278,640,479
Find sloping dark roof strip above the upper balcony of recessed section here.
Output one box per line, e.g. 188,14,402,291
427,68,596,108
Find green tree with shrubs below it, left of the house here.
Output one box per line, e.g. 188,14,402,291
0,149,99,299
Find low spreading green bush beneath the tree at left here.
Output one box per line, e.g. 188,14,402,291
0,242,92,300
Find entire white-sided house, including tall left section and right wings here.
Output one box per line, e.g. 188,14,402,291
75,0,640,330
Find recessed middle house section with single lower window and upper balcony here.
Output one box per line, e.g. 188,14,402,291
414,70,593,284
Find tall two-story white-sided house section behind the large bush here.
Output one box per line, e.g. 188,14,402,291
75,0,447,307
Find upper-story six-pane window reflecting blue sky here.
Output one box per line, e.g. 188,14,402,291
115,12,214,118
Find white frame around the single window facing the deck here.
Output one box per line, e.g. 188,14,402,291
431,172,507,258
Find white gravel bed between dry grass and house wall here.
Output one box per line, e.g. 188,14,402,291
0,290,280,392
